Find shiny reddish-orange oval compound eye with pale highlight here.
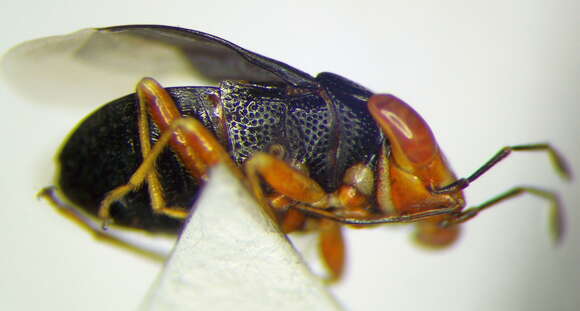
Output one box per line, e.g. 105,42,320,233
368,94,438,173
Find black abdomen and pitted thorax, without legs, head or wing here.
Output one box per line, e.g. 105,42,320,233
58,74,382,233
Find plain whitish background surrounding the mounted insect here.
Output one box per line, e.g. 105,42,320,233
0,0,580,310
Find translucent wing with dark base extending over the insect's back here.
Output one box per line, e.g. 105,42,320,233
2,25,315,102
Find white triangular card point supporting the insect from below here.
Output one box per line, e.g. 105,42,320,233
140,166,340,311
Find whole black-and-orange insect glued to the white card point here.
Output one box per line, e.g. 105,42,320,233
17,25,570,279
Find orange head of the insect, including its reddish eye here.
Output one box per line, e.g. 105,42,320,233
368,94,465,244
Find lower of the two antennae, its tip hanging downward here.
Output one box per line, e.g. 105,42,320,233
440,187,564,243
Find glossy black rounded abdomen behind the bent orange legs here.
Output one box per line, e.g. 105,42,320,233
58,87,216,233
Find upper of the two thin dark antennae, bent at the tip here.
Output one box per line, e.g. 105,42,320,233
433,144,572,194
